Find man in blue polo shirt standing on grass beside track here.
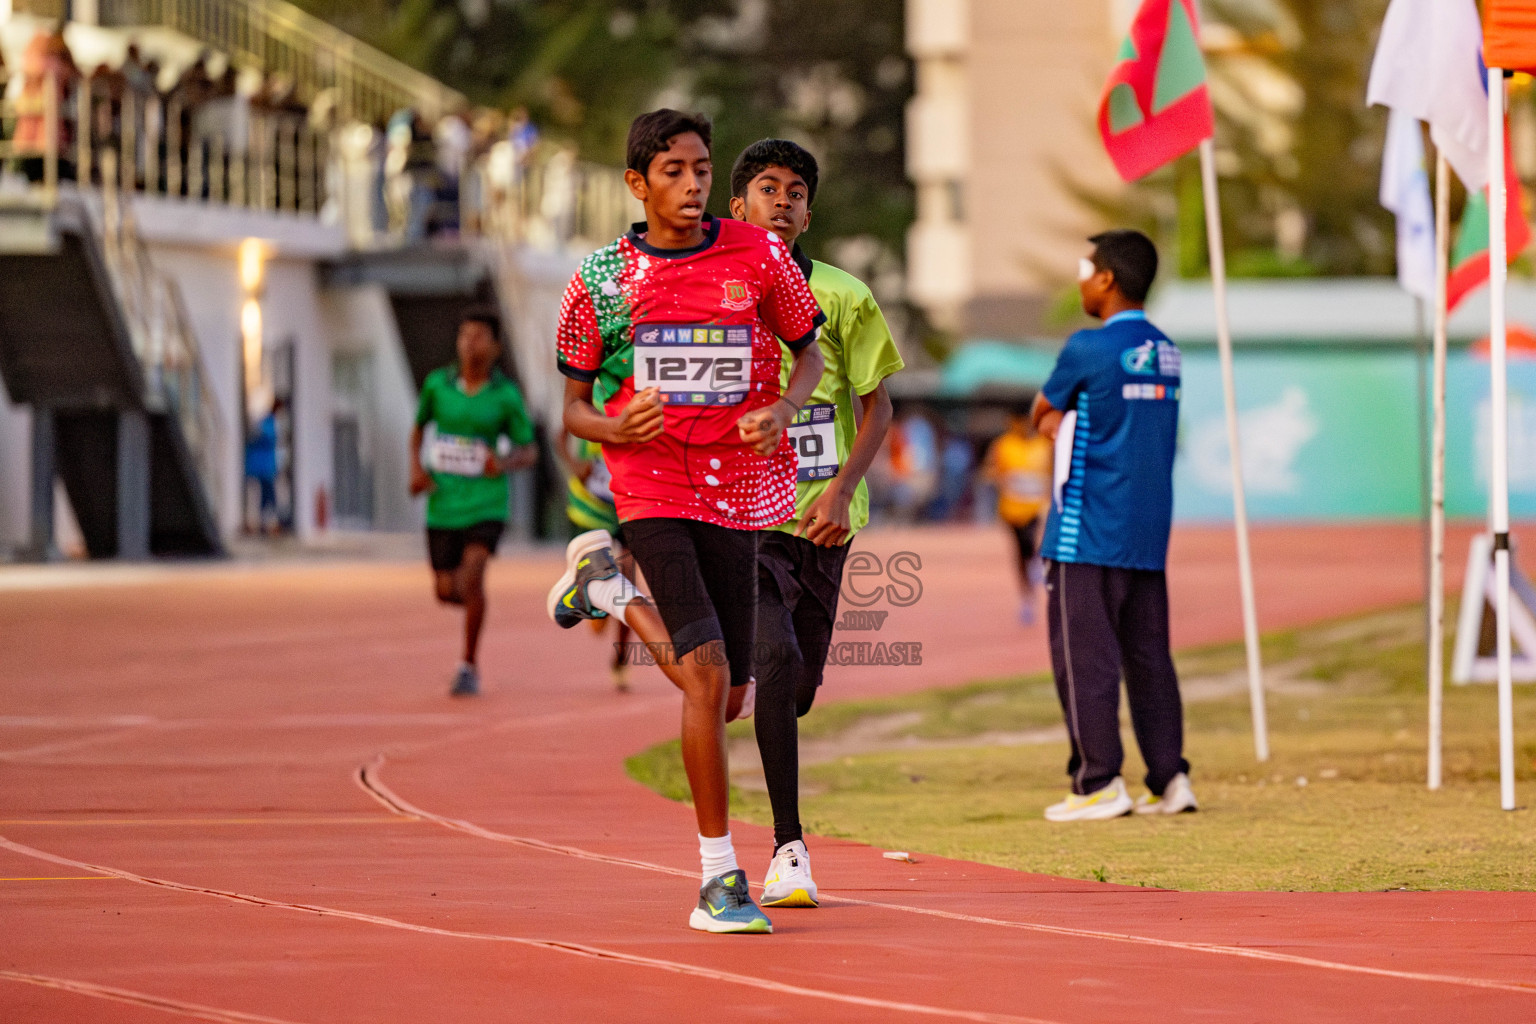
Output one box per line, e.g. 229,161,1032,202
1032,230,1195,821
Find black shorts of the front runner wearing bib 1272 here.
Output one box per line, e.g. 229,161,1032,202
619,519,757,686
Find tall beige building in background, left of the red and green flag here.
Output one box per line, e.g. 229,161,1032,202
908,0,1127,338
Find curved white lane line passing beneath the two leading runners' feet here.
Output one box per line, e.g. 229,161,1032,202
353,755,1536,995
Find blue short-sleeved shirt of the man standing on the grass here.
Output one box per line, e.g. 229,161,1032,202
1041,310,1181,571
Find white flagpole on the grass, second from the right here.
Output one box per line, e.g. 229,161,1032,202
1428,150,1450,789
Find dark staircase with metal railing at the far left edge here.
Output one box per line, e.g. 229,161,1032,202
0,178,224,559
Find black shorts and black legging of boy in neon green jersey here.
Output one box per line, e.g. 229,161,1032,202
754,530,849,851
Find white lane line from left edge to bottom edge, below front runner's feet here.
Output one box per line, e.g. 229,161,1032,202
0,837,1060,1024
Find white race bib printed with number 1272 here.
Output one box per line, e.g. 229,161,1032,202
634,324,753,405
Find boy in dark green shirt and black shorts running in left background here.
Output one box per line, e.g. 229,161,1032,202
410,310,538,697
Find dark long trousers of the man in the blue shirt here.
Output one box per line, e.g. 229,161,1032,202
1046,562,1189,797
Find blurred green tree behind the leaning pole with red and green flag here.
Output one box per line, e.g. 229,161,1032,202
1075,0,1395,278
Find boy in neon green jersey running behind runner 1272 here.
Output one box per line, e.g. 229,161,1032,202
731,138,903,907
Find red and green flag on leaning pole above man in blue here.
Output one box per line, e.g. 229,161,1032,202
1098,0,1217,181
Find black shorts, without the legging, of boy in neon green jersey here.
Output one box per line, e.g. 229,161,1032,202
757,530,852,692
